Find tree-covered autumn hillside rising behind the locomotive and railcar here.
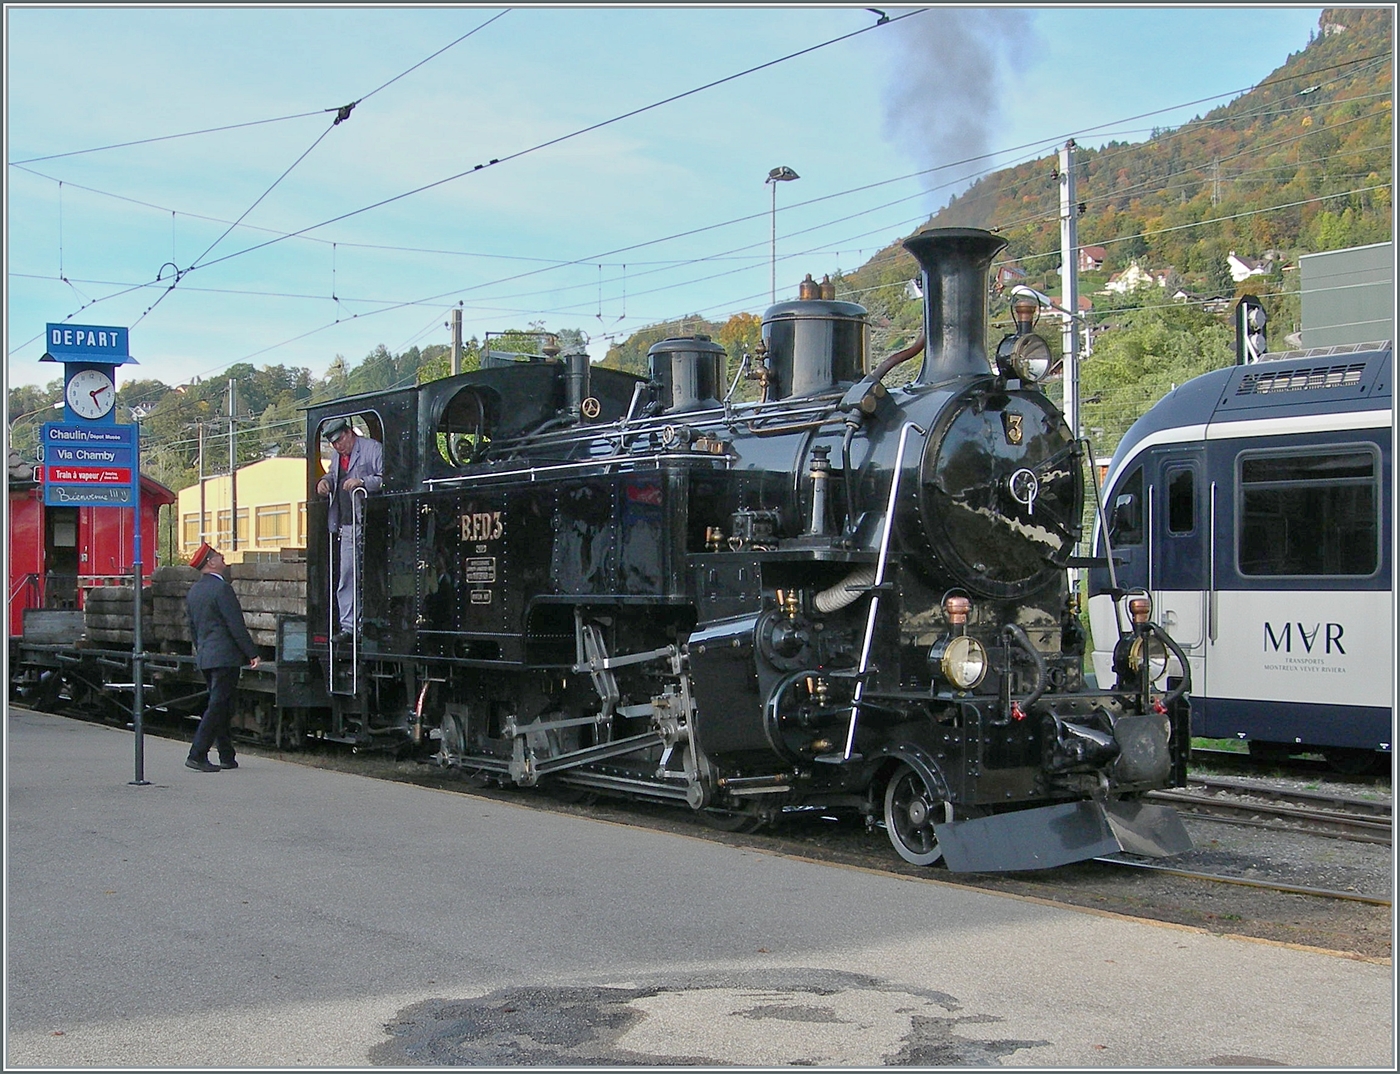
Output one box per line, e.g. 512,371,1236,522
609,8,1393,458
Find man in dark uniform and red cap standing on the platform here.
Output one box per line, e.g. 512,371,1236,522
185,543,258,772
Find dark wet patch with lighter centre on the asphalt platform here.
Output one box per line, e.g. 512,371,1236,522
370,969,1049,1067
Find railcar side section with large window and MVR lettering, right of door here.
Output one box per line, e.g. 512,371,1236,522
1207,431,1394,751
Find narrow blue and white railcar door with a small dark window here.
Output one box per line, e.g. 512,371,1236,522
1147,445,1211,697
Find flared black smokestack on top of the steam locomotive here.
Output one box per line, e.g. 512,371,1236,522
904,227,1007,384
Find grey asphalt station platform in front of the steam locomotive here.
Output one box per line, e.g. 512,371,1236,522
4,709,1394,1070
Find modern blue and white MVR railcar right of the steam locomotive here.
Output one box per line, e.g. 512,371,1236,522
1089,342,1394,770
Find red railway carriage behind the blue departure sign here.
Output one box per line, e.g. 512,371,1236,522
8,475,175,637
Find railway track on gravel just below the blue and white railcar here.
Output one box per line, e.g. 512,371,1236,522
1148,776,1392,846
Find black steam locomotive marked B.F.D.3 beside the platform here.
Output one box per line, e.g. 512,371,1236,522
298,228,1189,870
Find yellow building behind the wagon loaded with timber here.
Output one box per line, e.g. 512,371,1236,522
176,458,307,563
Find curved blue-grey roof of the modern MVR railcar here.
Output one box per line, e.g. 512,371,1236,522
1112,340,1392,470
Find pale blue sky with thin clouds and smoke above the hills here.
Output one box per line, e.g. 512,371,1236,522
4,4,1322,385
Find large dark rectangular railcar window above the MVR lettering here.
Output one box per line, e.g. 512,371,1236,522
1236,448,1380,577
